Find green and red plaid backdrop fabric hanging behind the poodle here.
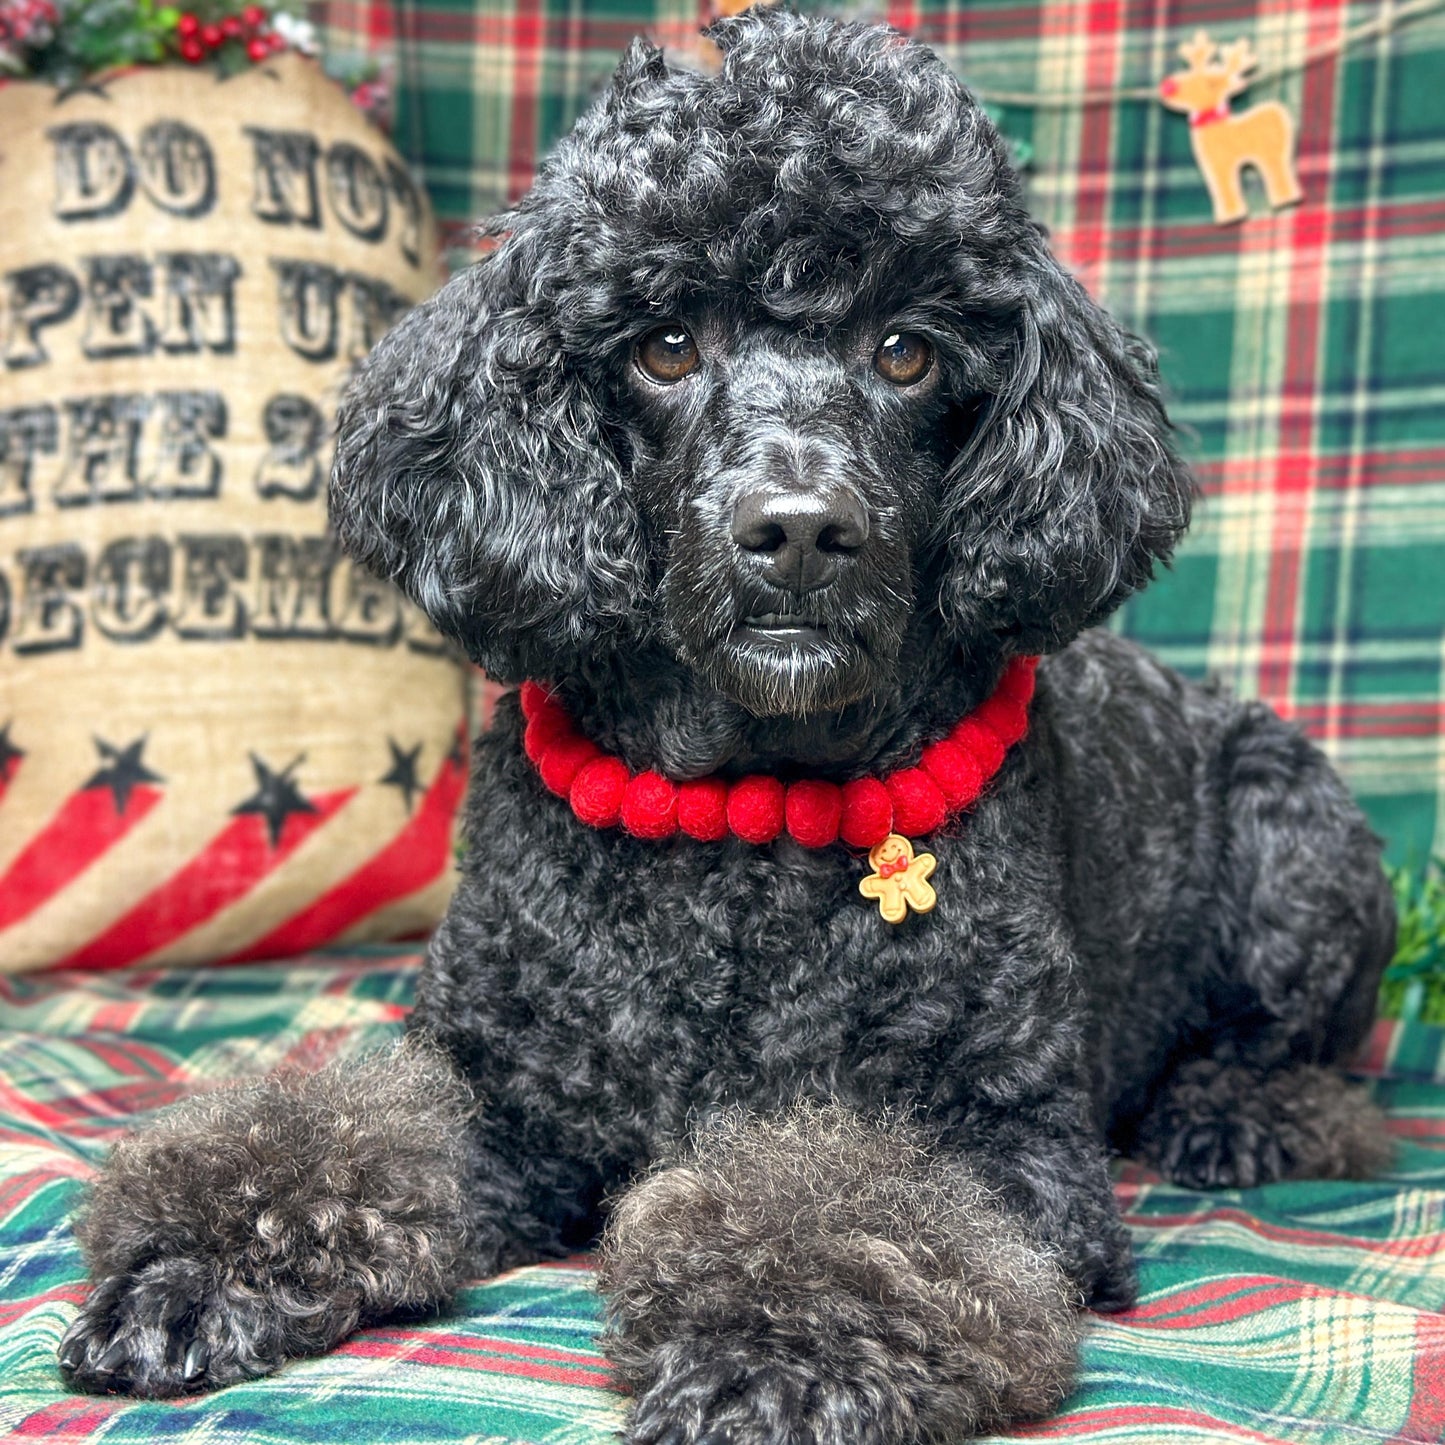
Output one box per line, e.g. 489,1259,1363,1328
310,0,1445,861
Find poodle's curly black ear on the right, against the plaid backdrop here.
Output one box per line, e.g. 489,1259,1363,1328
939,223,1194,652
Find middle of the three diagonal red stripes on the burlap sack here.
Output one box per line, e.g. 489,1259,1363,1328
55,788,357,968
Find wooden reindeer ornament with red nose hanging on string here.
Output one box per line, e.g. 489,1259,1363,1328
1159,30,1303,225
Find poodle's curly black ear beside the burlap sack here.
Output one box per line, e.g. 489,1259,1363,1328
329,239,646,679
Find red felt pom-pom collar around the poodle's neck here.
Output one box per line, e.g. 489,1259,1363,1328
522,657,1039,848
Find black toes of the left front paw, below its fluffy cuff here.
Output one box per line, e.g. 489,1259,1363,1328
58,1259,285,1397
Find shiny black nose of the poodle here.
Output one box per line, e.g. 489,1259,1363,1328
733,484,868,592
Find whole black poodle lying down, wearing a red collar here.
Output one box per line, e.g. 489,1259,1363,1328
61,10,1394,1445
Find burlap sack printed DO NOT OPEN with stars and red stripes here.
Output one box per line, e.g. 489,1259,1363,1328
0,55,465,970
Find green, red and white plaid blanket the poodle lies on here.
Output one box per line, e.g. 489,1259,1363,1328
0,952,1445,1445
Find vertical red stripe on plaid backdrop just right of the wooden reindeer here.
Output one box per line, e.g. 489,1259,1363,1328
1259,3,1342,718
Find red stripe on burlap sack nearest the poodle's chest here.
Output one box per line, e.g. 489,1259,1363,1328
220,739,467,964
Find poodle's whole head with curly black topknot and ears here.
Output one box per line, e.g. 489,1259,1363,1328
331,10,1191,715
